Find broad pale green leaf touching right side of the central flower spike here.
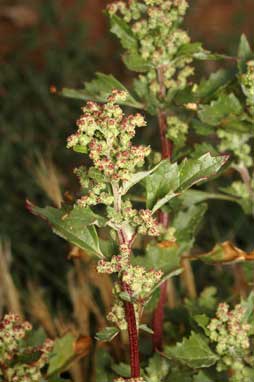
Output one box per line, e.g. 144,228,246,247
146,160,180,210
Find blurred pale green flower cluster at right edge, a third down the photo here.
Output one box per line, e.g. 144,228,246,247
218,129,253,167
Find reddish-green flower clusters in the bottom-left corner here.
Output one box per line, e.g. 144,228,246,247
0,314,54,382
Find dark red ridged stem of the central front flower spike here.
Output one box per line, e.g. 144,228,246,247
112,184,140,378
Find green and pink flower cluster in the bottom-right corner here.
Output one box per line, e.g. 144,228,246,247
208,303,250,382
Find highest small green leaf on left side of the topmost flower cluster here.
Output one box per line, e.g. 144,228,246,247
110,15,138,50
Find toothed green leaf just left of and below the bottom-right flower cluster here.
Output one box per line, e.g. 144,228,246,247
164,332,218,369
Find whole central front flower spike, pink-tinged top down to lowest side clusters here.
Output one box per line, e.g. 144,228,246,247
67,90,162,340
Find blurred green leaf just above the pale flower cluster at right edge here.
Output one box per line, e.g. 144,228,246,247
198,93,243,126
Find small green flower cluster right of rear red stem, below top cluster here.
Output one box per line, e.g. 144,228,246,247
167,116,189,149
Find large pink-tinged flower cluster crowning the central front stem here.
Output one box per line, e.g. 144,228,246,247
67,90,151,207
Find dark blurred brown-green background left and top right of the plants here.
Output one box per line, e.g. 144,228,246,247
0,0,254,368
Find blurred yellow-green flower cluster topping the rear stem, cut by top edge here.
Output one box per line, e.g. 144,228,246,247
107,0,194,95
